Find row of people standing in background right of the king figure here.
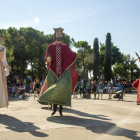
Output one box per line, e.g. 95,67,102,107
73,78,131,99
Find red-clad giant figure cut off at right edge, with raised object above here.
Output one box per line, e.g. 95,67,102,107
132,53,140,105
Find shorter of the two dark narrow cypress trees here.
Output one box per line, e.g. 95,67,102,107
93,38,99,80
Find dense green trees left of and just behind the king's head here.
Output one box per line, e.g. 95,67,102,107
0,27,75,78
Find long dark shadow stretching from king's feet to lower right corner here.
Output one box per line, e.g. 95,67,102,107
47,116,140,140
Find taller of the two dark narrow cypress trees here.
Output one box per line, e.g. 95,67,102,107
104,33,112,81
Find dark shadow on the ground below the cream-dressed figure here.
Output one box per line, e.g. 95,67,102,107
0,114,48,137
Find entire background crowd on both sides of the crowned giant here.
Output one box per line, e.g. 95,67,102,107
7,76,133,100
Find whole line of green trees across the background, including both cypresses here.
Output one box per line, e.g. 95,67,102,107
0,27,140,81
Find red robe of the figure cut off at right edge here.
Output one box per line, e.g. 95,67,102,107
132,79,140,105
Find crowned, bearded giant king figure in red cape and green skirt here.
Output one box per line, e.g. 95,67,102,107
38,27,78,116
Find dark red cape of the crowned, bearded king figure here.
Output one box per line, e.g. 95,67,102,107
45,43,78,91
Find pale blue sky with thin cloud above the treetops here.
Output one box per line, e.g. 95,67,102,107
0,0,140,67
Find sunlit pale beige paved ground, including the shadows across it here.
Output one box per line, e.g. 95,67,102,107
0,94,140,140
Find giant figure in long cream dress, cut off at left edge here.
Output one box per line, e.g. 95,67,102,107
0,33,11,108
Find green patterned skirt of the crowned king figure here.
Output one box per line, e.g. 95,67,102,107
38,70,72,106
